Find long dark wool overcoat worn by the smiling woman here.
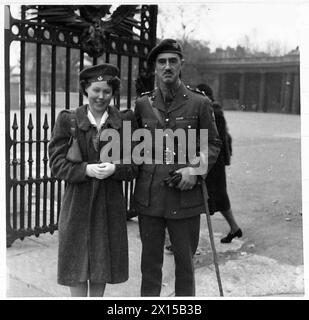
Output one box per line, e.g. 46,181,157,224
49,105,137,286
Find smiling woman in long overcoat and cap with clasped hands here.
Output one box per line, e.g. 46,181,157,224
49,64,137,296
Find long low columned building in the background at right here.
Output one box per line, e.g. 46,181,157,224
183,48,300,114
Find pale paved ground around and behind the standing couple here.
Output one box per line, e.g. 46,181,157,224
7,111,304,297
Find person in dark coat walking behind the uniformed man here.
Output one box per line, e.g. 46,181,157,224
197,84,242,243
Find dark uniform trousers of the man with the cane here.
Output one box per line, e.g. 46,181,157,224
139,215,200,296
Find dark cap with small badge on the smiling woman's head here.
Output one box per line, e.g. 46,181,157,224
79,63,119,82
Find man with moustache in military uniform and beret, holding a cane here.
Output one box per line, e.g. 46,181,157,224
134,39,221,296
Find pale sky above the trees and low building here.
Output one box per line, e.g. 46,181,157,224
157,0,301,53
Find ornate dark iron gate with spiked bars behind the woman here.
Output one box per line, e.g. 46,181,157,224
5,5,157,246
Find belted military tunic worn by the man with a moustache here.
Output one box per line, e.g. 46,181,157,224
134,83,221,219
